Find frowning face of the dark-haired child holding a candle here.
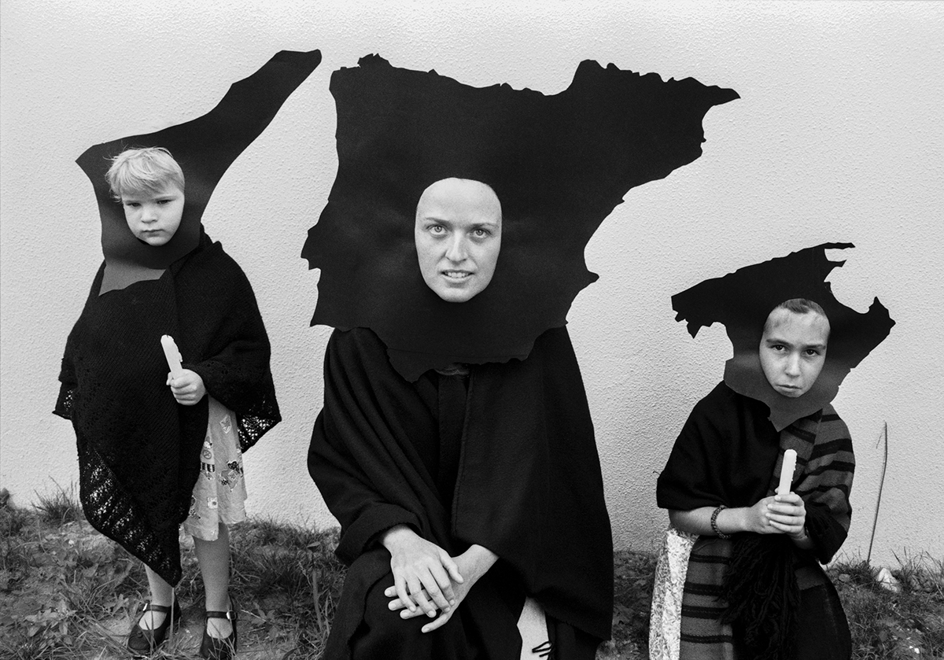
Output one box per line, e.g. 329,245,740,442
760,309,829,399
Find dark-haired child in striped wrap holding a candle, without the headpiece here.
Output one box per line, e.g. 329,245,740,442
650,299,854,660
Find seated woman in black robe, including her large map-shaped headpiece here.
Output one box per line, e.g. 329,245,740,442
303,56,737,660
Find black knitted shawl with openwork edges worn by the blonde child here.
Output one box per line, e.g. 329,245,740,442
55,234,281,584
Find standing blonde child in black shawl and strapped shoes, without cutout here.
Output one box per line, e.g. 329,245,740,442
55,147,280,658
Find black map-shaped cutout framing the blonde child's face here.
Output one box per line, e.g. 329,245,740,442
76,50,321,294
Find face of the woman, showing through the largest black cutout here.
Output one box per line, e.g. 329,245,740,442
413,179,502,302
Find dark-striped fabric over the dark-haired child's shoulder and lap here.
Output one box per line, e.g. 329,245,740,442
679,405,855,660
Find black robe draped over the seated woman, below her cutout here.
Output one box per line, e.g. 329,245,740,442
308,328,613,660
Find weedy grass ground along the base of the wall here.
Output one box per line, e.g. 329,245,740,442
0,496,944,660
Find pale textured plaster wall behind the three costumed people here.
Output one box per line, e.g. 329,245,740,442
0,0,944,562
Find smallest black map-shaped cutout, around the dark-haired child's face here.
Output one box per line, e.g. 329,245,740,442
672,243,895,431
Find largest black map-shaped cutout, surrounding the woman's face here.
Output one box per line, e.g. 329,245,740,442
302,55,738,380
